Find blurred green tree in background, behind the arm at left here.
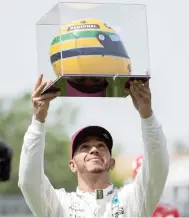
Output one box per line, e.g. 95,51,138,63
0,93,77,194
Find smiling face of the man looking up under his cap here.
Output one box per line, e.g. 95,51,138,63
69,137,115,173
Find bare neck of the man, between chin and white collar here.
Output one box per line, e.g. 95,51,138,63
78,173,111,192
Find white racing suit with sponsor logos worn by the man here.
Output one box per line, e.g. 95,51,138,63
18,115,169,218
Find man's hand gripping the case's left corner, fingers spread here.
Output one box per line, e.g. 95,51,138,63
32,74,60,123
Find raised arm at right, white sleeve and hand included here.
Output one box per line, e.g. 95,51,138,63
121,81,169,217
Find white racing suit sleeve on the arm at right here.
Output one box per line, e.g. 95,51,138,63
121,114,169,217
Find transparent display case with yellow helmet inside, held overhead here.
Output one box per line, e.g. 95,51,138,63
37,1,150,97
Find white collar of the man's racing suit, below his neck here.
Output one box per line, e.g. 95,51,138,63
76,184,114,200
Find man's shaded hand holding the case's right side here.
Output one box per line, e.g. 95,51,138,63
126,80,152,119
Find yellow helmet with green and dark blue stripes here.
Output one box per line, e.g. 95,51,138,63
50,19,131,77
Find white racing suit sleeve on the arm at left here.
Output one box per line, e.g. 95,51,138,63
18,118,66,217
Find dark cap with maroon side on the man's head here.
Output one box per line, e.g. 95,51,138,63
72,126,113,157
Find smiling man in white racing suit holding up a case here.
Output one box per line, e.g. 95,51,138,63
19,75,169,218
